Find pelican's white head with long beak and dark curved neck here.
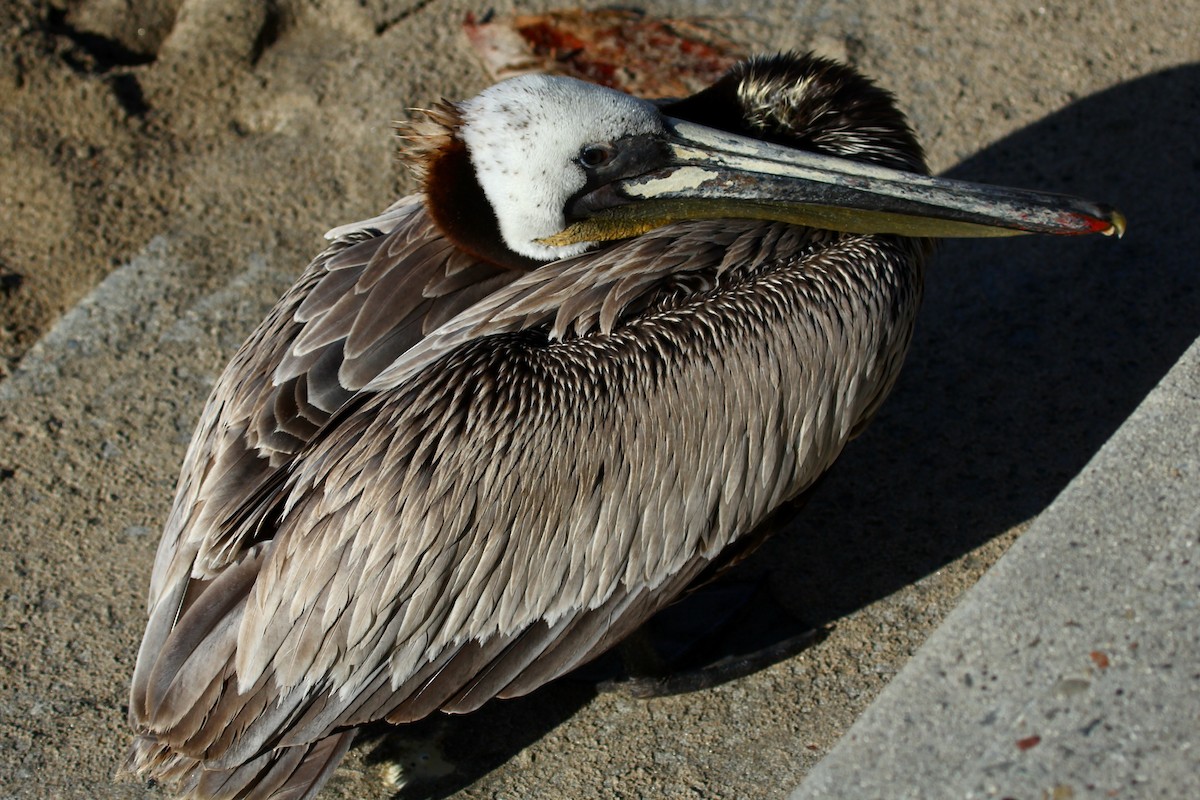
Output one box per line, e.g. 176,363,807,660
412,56,1124,272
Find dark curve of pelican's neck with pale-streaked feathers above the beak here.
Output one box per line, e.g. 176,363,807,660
661,53,929,174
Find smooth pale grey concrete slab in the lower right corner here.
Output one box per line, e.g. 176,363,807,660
791,341,1200,800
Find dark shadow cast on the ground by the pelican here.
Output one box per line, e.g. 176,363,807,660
367,66,1200,799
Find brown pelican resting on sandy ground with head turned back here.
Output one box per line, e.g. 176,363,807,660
128,55,1123,798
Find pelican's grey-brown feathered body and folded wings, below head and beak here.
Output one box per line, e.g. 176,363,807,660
130,199,919,799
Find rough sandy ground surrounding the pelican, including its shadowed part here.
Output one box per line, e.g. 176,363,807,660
0,0,1200,798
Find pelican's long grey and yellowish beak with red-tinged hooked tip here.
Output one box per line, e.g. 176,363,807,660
542,119,1126,245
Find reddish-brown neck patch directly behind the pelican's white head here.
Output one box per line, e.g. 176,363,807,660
425,138,541,272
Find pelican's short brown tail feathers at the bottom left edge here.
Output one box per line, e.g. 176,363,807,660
124,728,356,800
